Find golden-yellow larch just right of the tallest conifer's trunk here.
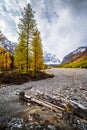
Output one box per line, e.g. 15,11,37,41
32,30,44,77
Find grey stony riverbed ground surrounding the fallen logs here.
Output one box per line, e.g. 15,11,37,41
0,68,87,130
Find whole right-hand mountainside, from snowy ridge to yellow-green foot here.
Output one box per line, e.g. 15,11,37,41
60,47,87,68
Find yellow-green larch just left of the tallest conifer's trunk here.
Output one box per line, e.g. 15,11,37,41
14,33,27,70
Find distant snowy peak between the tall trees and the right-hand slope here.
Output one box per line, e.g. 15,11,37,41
44,51,60,65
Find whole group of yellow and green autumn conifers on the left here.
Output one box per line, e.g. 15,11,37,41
0,4,44,77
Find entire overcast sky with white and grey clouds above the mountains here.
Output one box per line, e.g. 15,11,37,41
0,0,87,60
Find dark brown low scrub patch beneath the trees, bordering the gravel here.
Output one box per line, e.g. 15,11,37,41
0,71,54,84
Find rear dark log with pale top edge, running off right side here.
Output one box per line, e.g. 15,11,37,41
35,93,87,120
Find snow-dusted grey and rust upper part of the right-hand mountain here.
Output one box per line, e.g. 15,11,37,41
62,47,87,63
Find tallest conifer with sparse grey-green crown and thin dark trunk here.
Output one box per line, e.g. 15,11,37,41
18,4,36,71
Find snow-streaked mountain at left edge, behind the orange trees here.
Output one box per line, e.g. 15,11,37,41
0,36,17,53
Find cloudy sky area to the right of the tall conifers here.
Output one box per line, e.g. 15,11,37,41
31,0,87,58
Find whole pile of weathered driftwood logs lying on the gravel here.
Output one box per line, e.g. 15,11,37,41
19,92,87,121
